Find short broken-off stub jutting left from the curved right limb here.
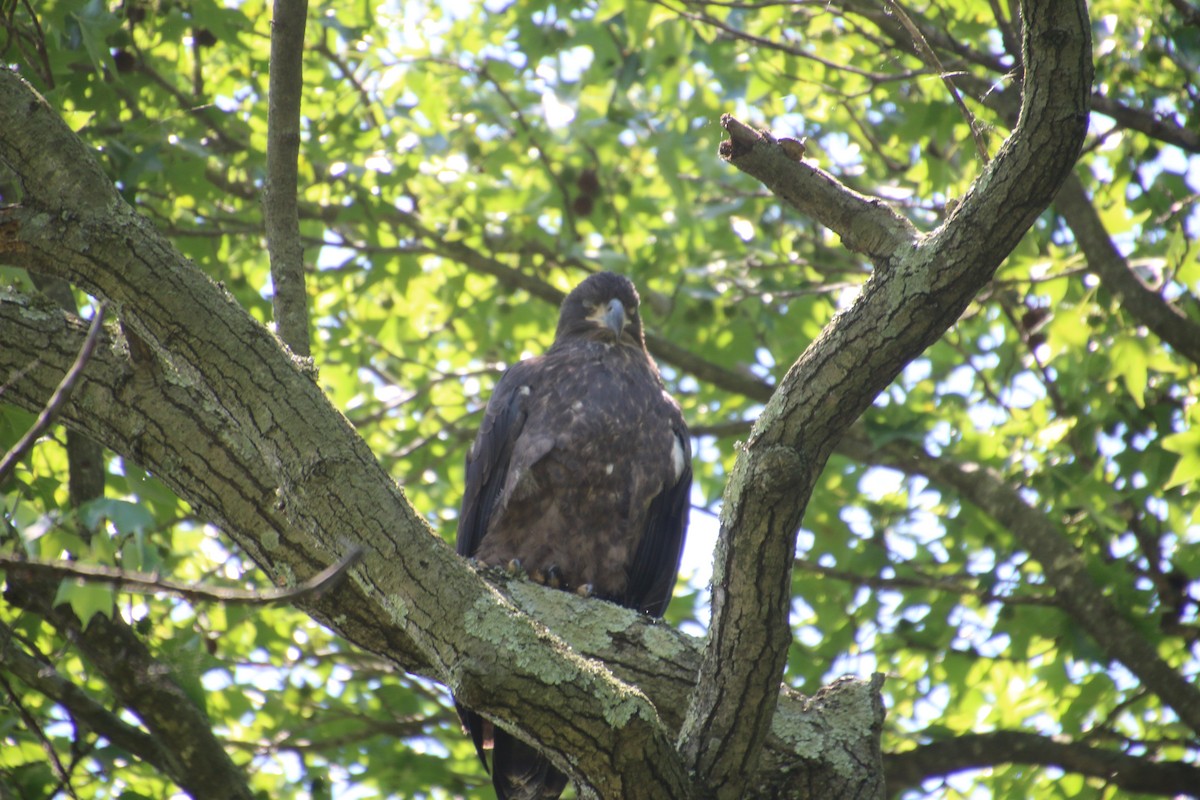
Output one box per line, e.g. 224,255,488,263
720,114,920,263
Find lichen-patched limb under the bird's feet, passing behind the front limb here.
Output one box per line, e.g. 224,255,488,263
0,297,883,796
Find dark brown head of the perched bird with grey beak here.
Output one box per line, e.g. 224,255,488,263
554,272,646,350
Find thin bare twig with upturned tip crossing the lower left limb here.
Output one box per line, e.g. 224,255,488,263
0,547,362,606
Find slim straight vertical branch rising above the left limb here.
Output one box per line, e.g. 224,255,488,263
263,0,311,356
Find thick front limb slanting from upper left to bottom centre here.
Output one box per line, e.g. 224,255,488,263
0,73,688,798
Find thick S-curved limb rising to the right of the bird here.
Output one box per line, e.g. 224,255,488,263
680,0,1092,798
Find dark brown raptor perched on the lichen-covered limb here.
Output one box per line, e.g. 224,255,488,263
456,272,691,800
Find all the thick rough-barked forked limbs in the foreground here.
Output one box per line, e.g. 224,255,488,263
0,0,1091,798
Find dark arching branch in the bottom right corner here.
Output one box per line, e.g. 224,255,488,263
883,730,1200,796
